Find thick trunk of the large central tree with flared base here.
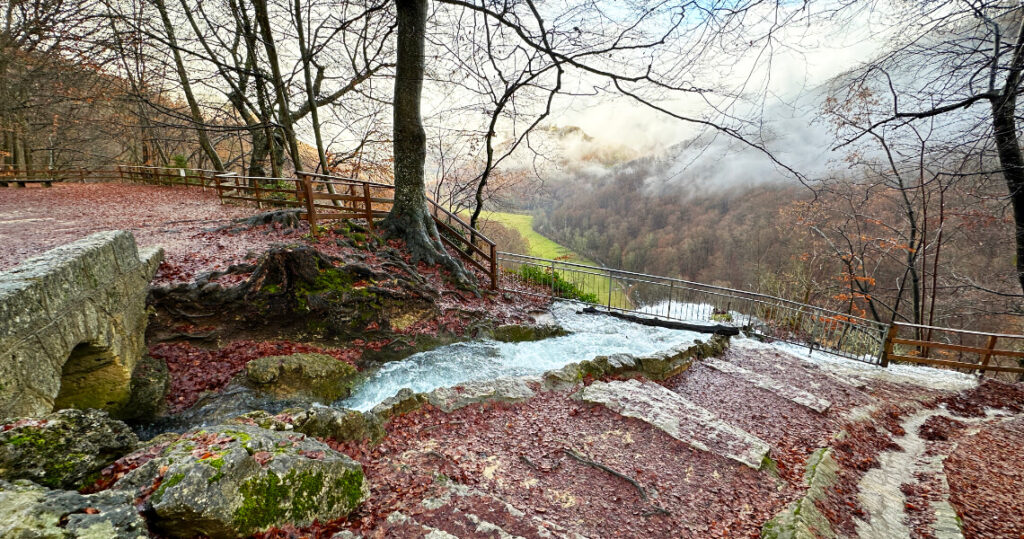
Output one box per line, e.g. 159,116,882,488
382,0,470,284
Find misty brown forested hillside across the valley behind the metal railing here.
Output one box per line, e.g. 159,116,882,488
535,150,1016,330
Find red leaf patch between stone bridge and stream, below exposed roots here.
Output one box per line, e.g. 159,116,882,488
150,340,362,413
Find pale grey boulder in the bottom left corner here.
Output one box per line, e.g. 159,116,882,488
0,481,150,539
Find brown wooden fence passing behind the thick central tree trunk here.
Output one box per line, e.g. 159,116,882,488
213,172,498,289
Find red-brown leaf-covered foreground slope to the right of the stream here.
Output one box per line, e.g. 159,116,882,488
253,347,1024,538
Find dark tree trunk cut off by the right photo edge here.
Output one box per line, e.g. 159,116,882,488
992,91,1024,291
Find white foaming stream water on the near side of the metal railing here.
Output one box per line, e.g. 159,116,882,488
338,302,708,411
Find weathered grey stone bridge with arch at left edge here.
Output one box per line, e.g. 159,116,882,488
0,231,163,418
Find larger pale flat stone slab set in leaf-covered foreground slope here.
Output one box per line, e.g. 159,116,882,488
578,379,770,469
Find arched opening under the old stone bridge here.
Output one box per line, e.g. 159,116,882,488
53,342,130,412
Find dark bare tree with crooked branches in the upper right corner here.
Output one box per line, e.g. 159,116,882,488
838,0,1024,290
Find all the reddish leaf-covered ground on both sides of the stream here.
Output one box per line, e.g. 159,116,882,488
8,184,1024,538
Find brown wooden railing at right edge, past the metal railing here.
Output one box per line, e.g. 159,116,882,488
882,323,1024,374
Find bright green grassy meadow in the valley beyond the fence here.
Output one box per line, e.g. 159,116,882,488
481,211,628,307
